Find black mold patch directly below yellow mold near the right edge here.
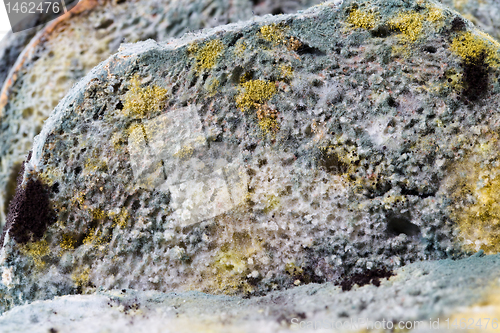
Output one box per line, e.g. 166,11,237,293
462,52,489,101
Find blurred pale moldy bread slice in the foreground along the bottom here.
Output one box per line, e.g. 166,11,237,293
0,255,500,333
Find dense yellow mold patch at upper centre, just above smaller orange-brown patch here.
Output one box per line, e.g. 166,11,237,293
236,80,277,111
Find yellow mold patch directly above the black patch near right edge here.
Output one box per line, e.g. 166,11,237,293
450,31,500,66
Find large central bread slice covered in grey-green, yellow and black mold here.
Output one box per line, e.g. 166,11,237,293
0,0,500,309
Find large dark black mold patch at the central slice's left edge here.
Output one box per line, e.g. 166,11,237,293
0,163,54,244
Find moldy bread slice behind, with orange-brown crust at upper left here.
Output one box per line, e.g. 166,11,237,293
0,0,319,230
